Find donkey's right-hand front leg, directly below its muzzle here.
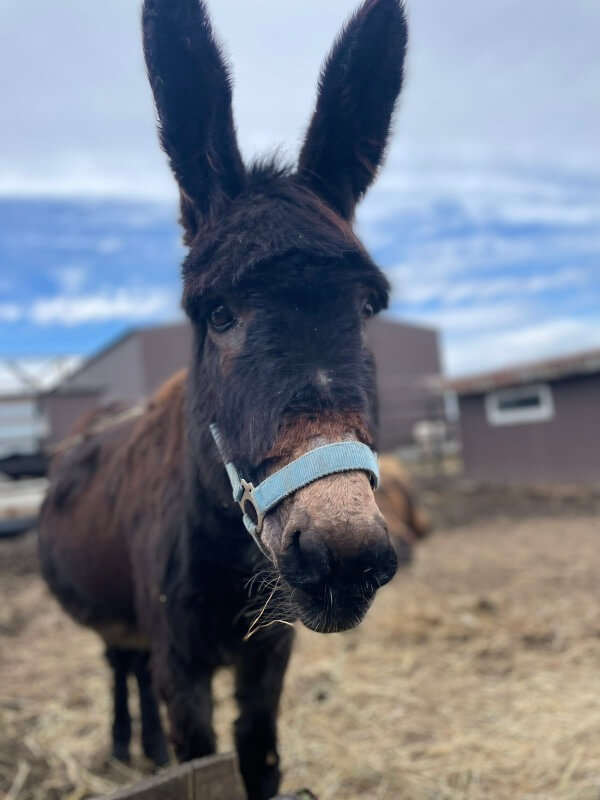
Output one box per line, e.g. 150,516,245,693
235,628,294,800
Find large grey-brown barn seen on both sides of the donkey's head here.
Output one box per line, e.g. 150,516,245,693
44,318,443,450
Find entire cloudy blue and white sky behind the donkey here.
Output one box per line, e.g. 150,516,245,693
0,0,600,378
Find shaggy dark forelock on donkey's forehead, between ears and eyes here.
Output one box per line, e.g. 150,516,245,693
183,163,389,308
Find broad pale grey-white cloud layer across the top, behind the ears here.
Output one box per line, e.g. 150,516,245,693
0,0,600,199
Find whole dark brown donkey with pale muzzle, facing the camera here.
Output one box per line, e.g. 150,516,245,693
40,0,406,800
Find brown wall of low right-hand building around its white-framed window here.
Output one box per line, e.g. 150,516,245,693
460,374,600,484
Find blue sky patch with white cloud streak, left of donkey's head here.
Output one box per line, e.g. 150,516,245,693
0,198,183,356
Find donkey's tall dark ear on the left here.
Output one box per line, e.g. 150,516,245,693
142,0,245,230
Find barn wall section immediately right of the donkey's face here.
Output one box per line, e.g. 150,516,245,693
369,319,445,450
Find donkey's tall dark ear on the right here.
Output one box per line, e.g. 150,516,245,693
298,0,407,219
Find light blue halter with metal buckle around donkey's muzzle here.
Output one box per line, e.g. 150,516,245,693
210,425,379,552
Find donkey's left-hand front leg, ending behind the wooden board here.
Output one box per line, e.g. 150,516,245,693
155,658,216,761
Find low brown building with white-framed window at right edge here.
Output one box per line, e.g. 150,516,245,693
447,350,600,484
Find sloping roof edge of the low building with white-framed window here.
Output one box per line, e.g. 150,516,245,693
444,349,600,395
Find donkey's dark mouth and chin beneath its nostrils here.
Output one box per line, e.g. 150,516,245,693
291,584,375,633
